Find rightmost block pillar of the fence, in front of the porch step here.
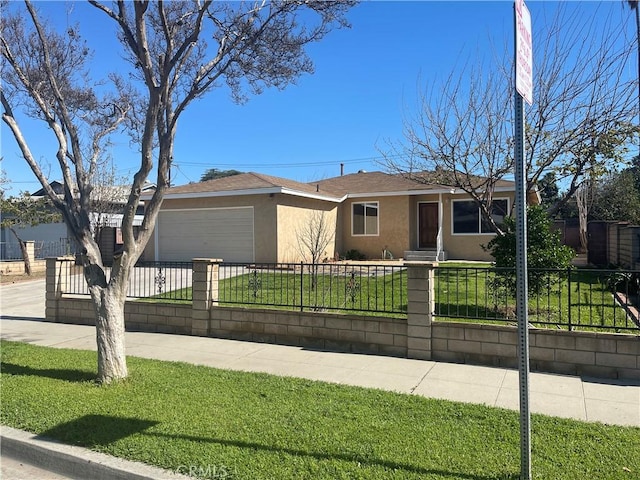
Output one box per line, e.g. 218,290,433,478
404,262,438,360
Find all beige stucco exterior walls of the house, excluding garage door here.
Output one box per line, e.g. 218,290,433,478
143,185,537,263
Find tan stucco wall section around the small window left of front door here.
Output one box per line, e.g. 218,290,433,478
339,196,411,259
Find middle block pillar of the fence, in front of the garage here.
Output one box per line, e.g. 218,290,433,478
191,258,222,337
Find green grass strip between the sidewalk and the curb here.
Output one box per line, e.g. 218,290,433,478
0,342,640,480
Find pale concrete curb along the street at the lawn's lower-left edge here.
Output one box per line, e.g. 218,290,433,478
0,425,191,480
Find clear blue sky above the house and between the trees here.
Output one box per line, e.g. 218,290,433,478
0,0,632,194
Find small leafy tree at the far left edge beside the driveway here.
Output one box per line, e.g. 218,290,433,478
0,192,62,275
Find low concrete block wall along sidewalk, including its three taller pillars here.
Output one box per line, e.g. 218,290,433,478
45,259,640,379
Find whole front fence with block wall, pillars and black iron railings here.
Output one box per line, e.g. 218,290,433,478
46,258,640,379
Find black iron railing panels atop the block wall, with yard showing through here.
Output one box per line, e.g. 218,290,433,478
61,262,640,333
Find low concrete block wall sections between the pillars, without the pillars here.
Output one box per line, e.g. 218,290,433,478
47,295,640,379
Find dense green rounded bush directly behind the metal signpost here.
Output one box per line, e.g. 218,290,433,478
486,205,575,293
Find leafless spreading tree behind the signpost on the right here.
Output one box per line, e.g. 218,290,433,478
383,4,639,233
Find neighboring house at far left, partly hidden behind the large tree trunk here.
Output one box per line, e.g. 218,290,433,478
0,181,155,263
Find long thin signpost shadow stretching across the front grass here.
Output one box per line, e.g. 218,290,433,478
144,432,520,480
